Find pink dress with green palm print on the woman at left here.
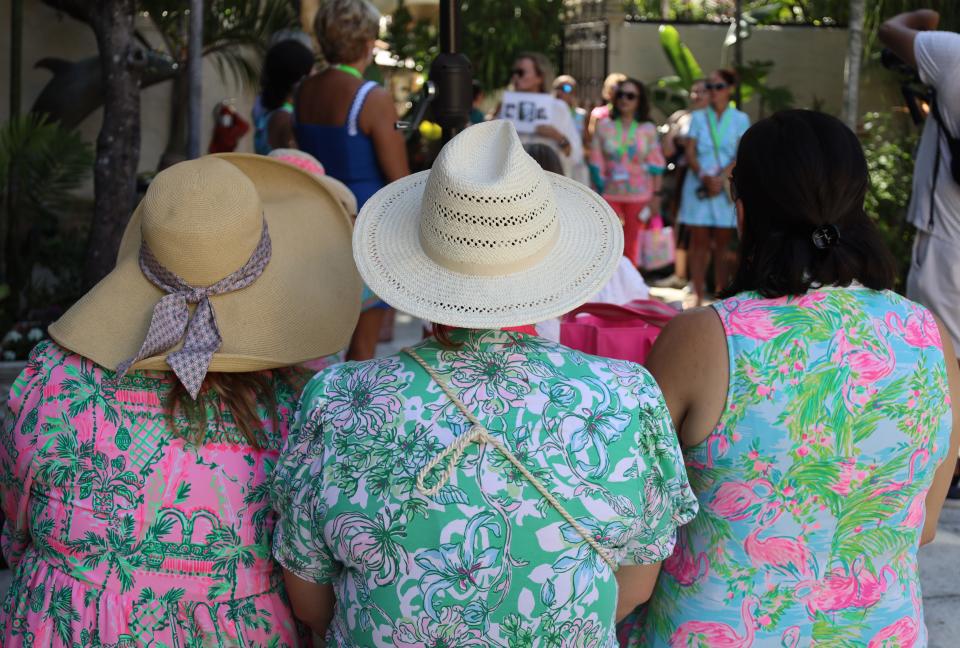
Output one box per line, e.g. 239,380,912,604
0,342,306,648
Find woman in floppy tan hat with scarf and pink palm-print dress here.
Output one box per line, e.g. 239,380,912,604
0,154,360,646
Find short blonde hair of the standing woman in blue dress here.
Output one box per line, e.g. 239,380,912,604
313,0,380,63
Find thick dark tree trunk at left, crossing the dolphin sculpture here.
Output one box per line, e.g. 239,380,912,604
83,0,146,288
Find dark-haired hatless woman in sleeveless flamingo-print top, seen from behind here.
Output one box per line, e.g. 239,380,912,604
630,111,960,648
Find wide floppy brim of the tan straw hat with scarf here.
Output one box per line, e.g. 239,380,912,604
50,153,362,372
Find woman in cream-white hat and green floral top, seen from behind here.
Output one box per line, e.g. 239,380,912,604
273,121,697,648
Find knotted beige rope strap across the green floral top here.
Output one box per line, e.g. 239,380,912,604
403,348,617,571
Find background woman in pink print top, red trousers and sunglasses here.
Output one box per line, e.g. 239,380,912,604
590,79,666,267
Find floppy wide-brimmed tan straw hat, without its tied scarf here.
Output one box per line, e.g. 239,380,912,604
50,153,362,372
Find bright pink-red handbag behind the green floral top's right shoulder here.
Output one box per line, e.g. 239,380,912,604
560,299,680,364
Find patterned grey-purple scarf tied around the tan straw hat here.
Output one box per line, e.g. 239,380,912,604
116,220,272,400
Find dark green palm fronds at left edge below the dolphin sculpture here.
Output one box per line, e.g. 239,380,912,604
0,114,93,330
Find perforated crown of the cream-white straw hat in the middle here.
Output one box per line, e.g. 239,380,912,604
420,122,561,276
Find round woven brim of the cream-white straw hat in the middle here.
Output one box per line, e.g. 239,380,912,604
353,171,623,328
